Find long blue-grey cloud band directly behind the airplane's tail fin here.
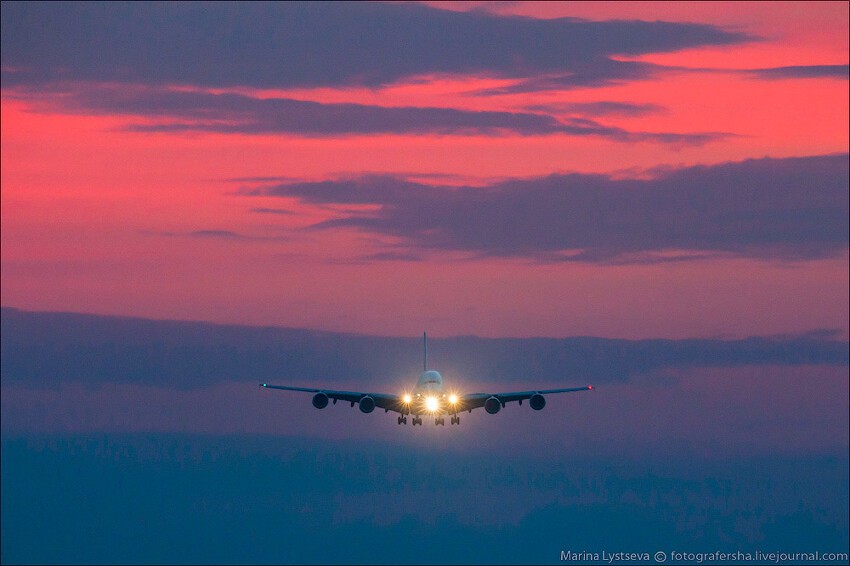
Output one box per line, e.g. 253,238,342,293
0,308,848,389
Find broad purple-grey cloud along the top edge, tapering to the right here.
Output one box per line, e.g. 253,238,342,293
0,2,754,88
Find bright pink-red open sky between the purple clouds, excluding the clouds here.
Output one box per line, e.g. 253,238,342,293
0,2,850,338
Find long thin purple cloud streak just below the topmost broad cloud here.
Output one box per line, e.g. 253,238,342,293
31,84,732,144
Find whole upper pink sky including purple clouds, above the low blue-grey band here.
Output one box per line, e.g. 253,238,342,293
0,2,848,339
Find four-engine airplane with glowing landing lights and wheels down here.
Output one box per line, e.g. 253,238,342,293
260,333,593,426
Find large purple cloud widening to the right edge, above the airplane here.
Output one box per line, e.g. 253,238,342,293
248,154,850,263
